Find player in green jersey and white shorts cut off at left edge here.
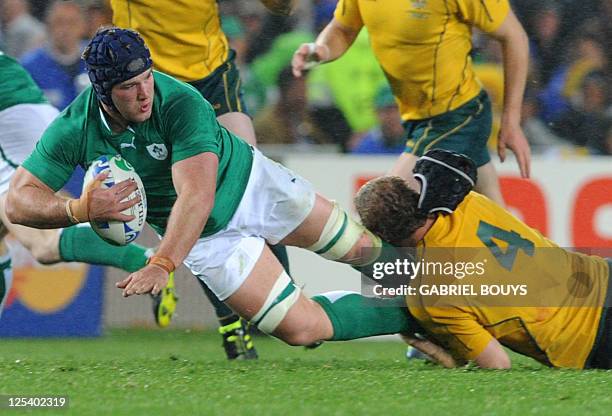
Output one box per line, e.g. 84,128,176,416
0,51,154,313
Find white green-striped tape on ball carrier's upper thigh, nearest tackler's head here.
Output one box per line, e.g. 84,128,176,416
308,203,365,260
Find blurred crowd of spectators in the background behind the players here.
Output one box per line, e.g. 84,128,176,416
0,0,612,155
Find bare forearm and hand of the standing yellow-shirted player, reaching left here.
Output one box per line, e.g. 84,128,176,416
291,18,361,77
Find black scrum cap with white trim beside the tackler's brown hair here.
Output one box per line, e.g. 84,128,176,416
412,149,478,214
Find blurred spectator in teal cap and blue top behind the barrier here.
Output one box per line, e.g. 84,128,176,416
351,85,405,155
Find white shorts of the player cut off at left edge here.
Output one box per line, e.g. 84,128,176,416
0,104,59,195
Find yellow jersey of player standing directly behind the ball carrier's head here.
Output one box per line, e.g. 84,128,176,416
111,0,229,82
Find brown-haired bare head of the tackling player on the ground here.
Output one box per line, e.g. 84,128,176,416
355,176,427,245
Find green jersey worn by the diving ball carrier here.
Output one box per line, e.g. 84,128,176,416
23,71,253,237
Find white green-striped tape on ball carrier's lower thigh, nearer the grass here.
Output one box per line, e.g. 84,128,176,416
251,270,301,334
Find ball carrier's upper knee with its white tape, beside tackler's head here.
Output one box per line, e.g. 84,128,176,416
308,203,382,265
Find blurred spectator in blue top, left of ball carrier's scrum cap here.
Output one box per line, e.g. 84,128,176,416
21,0,89,110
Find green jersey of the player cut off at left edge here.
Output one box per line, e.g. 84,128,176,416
0,51,48,111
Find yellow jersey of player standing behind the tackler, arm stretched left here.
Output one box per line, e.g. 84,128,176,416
334,0,510,120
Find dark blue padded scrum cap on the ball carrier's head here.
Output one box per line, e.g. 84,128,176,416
82,27,153,108
